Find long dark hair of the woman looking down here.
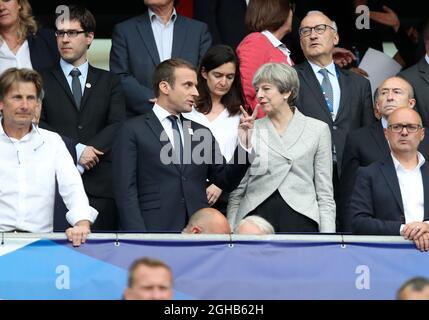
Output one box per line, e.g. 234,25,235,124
196,45,244,115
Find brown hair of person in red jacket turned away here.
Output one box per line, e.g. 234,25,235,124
245,0,291,32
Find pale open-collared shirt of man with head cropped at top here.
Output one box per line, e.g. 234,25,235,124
148,8,177,62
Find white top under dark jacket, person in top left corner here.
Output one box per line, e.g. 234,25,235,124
0,40,33,74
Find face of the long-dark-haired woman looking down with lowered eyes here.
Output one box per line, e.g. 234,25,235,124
201,62,236,98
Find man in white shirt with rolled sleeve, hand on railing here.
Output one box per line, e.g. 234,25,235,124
0,68,97,246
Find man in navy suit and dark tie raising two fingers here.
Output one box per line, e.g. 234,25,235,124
113,59,256,232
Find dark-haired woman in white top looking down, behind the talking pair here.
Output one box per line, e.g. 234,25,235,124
183,45,244,212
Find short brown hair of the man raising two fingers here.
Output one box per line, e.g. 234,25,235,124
152,58,197,98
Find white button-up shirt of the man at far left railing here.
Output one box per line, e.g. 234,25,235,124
0,125,98,233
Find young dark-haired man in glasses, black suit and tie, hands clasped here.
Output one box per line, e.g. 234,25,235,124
40,6,125,230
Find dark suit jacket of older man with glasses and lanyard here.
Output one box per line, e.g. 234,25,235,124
295,61,376,176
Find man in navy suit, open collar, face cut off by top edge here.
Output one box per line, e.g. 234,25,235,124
110,0,211,117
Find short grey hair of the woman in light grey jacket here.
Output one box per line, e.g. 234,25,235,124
252,63,299,106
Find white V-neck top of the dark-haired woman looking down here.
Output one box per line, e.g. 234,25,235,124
182,108,240,161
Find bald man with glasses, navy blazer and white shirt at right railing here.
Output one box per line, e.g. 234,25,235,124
350,107,429,251
